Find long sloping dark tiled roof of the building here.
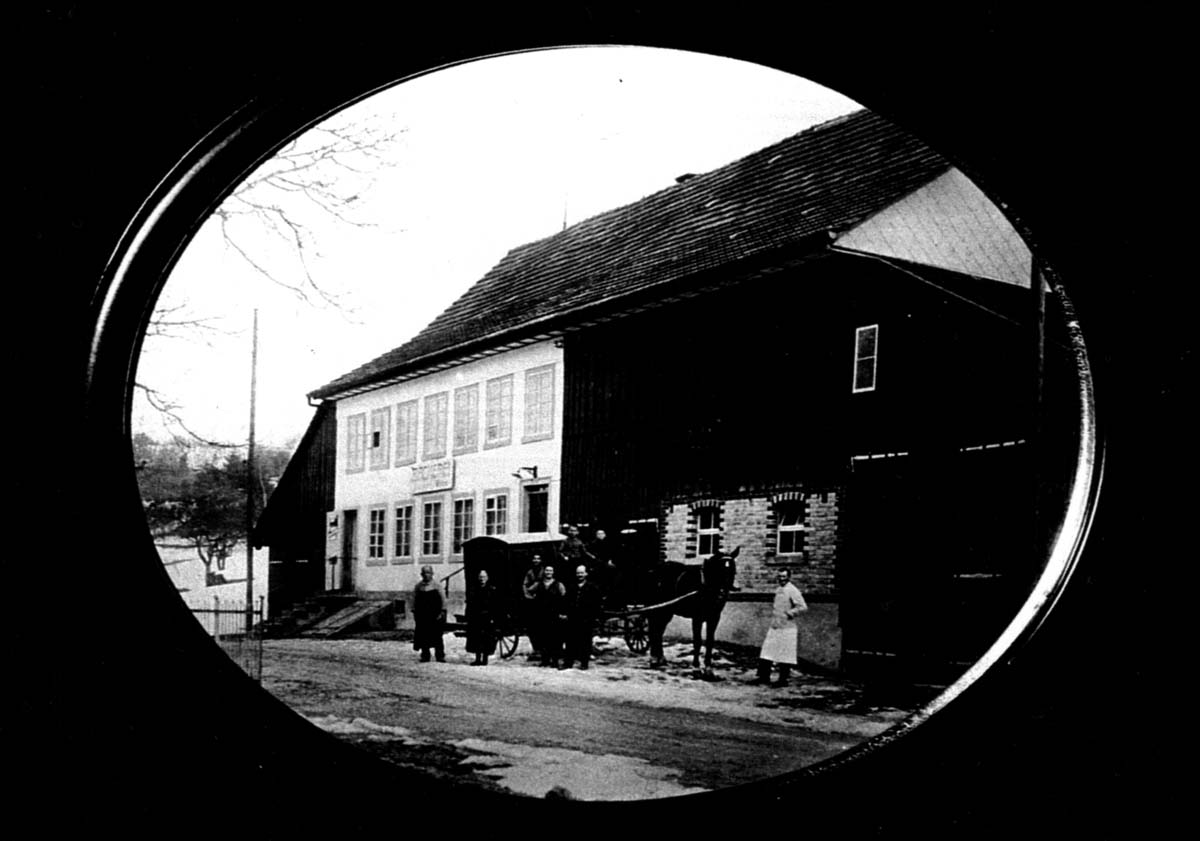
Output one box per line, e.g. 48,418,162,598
310,110,949,397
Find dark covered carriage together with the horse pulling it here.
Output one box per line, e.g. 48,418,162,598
458,537,738,667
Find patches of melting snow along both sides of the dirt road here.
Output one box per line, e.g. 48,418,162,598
274,635,926,800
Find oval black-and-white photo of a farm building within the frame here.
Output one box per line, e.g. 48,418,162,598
124,41,1093,800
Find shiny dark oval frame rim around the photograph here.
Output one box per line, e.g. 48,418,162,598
85,43,1102,803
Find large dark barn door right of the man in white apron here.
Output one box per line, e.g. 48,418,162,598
839,447,1038,681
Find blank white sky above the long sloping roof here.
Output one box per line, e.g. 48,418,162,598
133,47,859,446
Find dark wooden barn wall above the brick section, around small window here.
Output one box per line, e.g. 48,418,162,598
562,250,1032,524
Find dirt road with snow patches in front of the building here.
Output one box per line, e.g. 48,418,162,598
263,637,926,800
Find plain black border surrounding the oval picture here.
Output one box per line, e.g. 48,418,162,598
25,4,1190,837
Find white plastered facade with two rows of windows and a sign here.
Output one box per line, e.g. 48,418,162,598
330,341,563,594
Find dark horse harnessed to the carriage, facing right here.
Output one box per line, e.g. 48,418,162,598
647,546,742,677
